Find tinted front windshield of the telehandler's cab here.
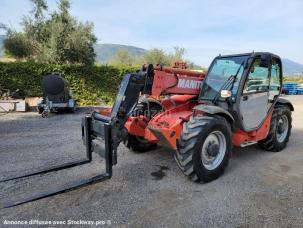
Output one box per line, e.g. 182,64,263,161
200,55,249,100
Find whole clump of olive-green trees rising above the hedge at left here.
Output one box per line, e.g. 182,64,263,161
5,0,97,64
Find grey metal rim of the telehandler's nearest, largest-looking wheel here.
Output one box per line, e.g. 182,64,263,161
201,131,226,170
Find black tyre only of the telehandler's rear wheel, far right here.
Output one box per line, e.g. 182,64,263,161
258,106,292,152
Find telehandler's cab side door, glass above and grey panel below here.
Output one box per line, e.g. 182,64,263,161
239,57,270,131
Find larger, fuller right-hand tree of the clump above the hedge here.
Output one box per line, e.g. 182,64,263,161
41,0,97,64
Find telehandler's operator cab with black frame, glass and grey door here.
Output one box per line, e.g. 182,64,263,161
199,52,282,131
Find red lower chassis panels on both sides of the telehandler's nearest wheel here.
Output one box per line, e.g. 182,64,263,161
125,108,272,149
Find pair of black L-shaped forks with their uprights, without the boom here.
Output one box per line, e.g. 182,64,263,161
0,116,113,208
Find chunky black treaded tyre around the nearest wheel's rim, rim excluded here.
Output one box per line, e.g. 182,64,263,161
175,116,232,182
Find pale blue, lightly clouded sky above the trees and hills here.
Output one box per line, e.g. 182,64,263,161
0,0,303,66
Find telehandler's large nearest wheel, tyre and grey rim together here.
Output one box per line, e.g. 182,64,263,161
175,116,232,182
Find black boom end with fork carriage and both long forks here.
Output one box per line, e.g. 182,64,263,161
0,65,153,207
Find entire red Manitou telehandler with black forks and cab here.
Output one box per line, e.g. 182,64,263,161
1,52,294,206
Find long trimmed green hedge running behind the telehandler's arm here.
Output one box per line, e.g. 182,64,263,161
0,62,138,105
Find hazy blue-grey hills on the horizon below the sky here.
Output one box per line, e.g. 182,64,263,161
0,35,303,76
